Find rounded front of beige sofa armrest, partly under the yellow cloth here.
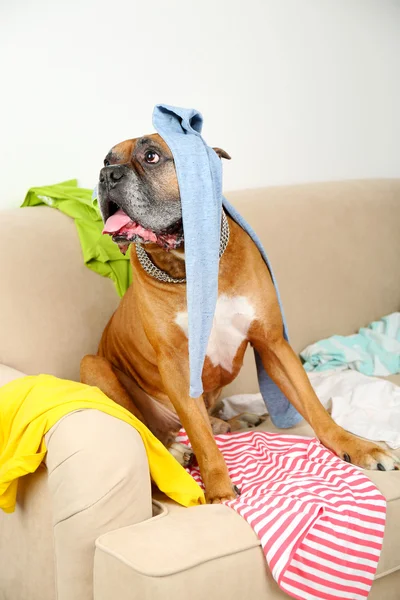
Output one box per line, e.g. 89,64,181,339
46,410,152,600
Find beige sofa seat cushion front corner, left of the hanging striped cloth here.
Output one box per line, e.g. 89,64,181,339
94,501,287,600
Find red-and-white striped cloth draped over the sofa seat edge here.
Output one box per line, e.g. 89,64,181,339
177,430,386,600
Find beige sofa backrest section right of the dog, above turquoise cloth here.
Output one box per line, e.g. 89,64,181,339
225,179,400,394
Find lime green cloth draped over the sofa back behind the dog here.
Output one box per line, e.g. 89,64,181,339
22,179,132,296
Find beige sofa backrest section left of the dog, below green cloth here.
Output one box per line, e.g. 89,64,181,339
0,207,119,379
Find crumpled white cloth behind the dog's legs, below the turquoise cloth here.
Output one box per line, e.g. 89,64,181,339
221,369,400,449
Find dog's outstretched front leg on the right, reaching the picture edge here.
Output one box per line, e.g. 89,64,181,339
250,323,399,471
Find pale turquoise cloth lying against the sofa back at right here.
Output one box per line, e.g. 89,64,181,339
300,312,400,376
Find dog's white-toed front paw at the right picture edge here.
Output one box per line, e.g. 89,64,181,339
332,434,400,471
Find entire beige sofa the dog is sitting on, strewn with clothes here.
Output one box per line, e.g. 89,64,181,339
0,180,400,600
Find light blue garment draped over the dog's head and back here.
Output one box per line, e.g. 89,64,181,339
153,104,302,428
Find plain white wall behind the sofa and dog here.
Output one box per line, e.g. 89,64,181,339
0,0,400,208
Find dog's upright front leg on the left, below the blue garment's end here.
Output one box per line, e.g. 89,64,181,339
158,354,236,504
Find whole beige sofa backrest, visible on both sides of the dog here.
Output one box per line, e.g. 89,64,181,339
0,179,400,392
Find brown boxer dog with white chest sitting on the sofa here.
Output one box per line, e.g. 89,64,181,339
81,134,399,503
